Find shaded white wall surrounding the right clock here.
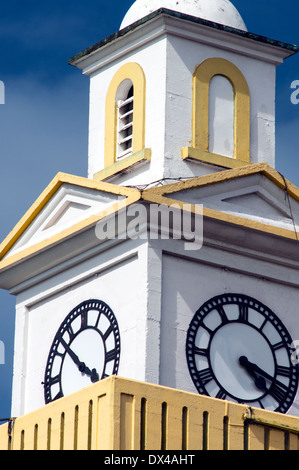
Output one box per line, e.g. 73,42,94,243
160,248,299,416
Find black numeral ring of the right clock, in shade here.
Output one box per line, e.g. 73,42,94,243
186,293,299,413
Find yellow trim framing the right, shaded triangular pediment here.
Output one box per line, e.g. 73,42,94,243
142,163,299,241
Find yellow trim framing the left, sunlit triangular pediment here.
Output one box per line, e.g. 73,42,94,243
0,173,140,270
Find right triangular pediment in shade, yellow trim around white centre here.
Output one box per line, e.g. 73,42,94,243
142,164,299,237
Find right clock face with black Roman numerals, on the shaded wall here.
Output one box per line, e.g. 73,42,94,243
186,294,298,413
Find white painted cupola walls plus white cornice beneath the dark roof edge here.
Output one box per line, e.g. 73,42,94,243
84,11,277,185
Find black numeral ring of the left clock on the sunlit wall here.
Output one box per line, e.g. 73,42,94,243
43,299,121,404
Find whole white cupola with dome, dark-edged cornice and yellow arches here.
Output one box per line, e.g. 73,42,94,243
70,0,296,186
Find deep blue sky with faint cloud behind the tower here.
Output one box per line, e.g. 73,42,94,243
0,0,299,419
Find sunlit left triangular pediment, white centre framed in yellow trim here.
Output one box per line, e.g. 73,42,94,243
0,173,139,259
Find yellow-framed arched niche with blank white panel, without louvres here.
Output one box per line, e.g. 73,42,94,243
182,57,250,168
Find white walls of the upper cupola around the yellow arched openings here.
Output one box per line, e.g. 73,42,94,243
88,23,275,184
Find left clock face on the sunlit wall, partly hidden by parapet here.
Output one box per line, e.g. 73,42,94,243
44,300,120,403
